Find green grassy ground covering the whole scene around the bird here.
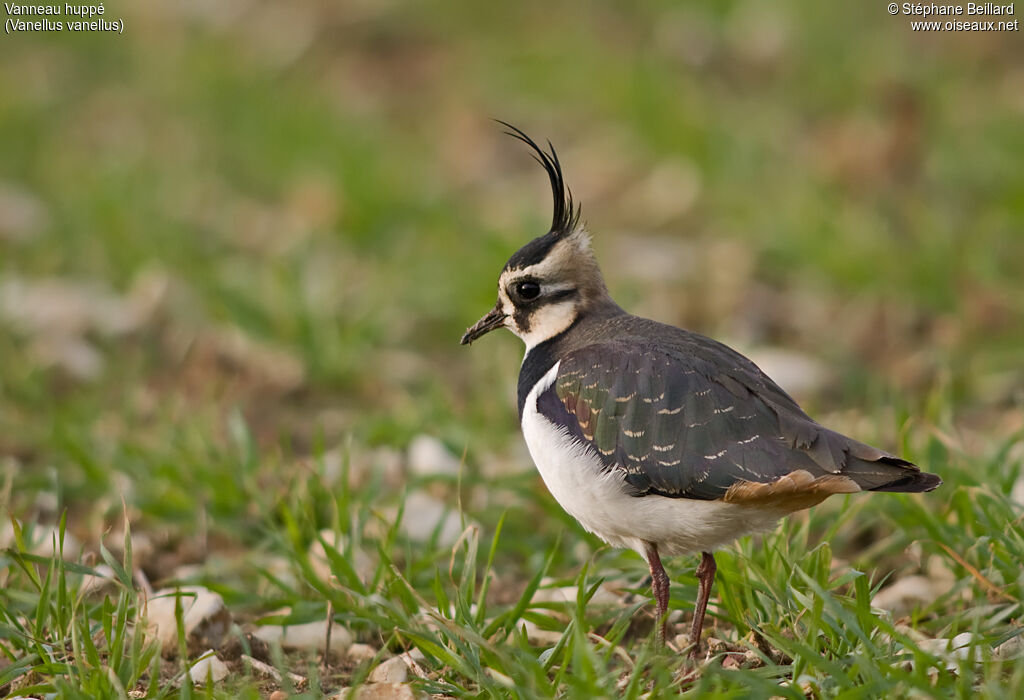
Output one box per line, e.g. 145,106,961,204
0,1,1024,698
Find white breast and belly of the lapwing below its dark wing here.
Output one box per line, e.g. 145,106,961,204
522,363,782,556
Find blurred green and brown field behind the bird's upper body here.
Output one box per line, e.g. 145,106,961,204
0,0,1024,687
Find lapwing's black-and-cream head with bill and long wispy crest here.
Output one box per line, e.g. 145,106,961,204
462,122,613,350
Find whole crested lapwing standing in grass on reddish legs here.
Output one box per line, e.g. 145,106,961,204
461,120,942,660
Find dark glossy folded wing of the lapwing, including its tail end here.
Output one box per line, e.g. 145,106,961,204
538,336,941,499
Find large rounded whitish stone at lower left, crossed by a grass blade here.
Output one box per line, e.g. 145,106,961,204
145,585,231,655
